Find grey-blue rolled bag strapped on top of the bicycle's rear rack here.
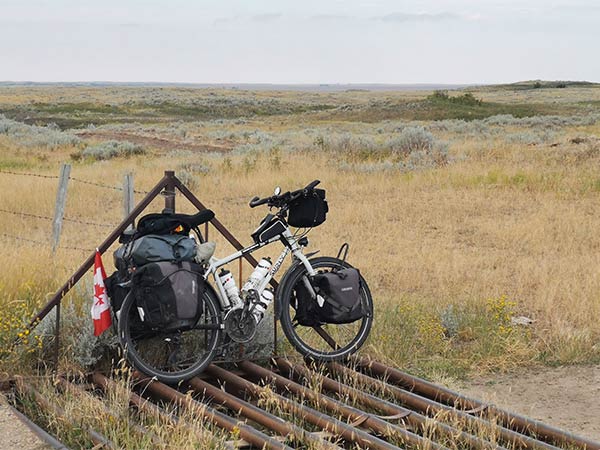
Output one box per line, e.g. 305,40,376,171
126,234,197,266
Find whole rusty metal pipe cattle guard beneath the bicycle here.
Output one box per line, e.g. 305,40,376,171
7,357,600,450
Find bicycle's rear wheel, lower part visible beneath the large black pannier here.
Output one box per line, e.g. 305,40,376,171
119,288,222,384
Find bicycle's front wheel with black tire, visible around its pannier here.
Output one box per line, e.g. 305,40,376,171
277,256,373,362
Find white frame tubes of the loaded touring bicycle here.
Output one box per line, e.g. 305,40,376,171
204,227,316,311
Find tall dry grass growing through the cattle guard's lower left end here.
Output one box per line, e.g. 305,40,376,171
15,372,229,450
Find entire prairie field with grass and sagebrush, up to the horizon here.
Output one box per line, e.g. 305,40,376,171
0,83,600,446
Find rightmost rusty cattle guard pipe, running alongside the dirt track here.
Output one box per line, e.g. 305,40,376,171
353,357,600,450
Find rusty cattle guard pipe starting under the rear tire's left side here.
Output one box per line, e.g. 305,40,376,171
133,372,292,450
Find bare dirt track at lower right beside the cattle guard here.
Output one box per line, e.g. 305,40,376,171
459,366,600,441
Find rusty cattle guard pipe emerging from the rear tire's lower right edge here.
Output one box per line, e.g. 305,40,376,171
207,364,398,450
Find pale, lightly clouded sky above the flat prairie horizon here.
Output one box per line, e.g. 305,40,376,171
0,0,600,84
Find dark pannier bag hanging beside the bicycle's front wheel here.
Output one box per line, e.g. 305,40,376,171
313,268,366,324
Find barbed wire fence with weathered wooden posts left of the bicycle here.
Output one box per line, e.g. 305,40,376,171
0,164,143,254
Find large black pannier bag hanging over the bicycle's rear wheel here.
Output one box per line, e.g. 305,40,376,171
132,261,205,331
